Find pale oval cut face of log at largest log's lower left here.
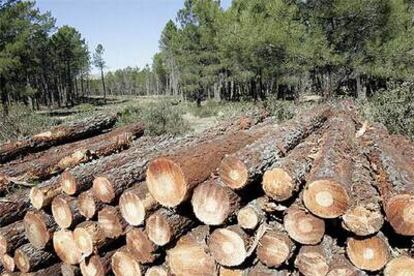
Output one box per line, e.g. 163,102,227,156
119,191,146,226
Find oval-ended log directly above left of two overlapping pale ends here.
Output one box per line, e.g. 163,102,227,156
52,194,83,228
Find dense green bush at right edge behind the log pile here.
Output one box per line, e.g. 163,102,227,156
360,81,414,139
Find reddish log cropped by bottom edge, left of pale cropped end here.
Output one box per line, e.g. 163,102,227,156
79,250,116,276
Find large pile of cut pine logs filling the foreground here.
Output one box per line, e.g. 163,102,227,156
0,104,414,276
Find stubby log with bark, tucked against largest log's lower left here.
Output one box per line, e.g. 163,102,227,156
119,183,160,226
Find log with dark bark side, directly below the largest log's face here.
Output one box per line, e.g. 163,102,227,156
145,208,195,246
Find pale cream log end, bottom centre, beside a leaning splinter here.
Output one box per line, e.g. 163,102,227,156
208,229,247,266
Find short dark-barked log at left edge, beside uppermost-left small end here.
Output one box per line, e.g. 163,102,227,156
0,190,31,226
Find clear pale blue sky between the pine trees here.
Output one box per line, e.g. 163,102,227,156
36,0,231,73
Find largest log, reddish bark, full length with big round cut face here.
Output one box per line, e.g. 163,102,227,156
146,127,269,207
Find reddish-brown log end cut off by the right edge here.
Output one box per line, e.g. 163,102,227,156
385,194,414,236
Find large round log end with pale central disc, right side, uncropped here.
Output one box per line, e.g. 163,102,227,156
303,180,349,218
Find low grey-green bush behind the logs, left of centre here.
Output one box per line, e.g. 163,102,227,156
118,101,190,135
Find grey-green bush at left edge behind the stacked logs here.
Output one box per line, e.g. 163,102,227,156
0,104,57,142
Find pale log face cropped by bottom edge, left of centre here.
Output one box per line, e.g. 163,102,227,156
111,251,141,276
